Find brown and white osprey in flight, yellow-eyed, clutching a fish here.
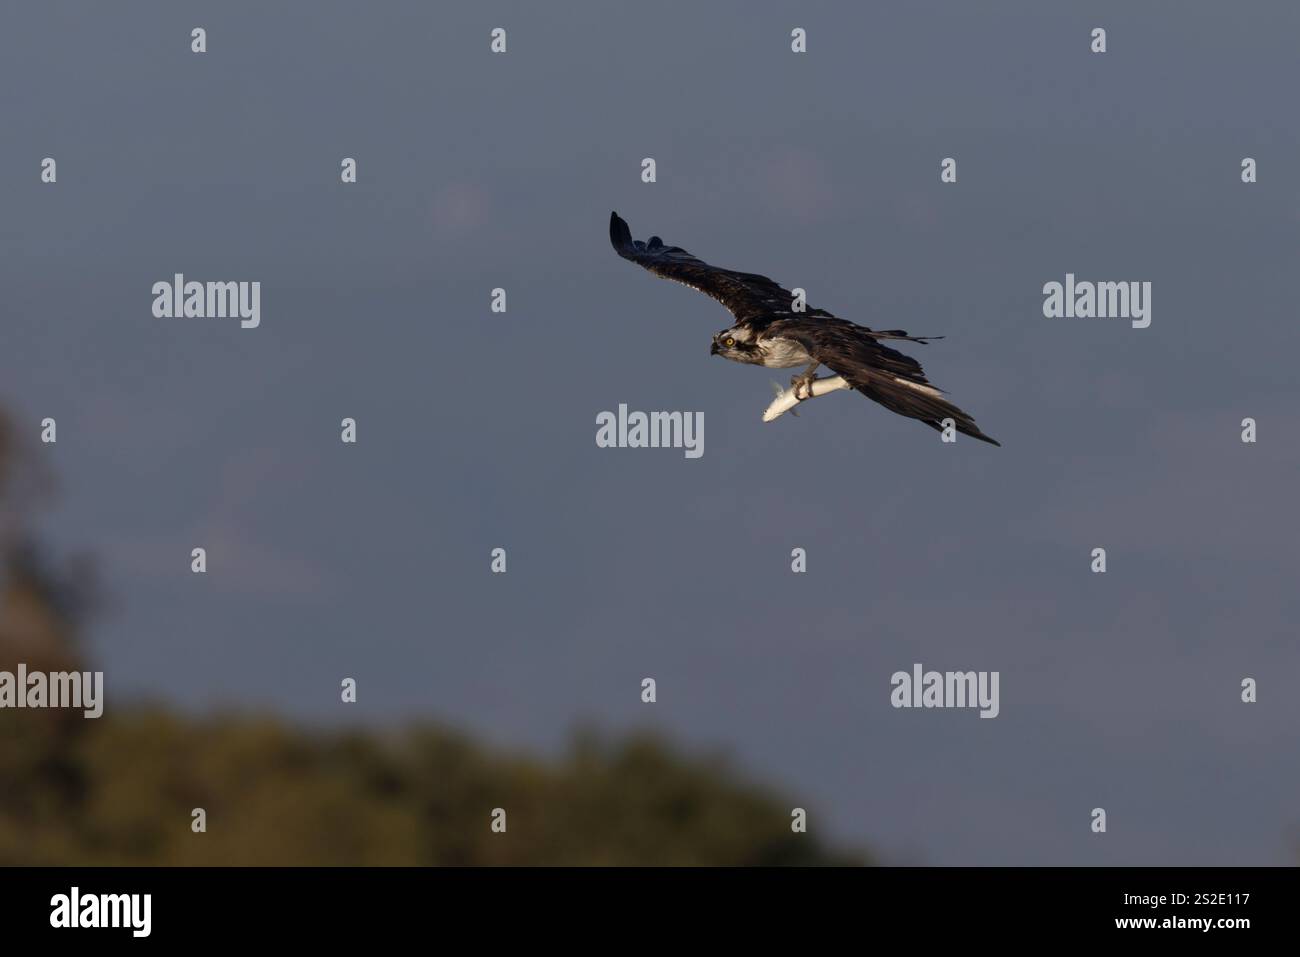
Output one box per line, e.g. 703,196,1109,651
610,213,1001,446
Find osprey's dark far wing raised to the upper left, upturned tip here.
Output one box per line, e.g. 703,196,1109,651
610,213,831,328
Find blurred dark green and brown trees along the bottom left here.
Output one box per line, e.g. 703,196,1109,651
0,405,863,865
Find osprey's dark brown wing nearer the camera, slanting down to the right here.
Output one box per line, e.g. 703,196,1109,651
766,317,1001,446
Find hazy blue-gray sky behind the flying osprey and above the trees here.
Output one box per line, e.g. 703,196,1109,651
0,3,1300,865
